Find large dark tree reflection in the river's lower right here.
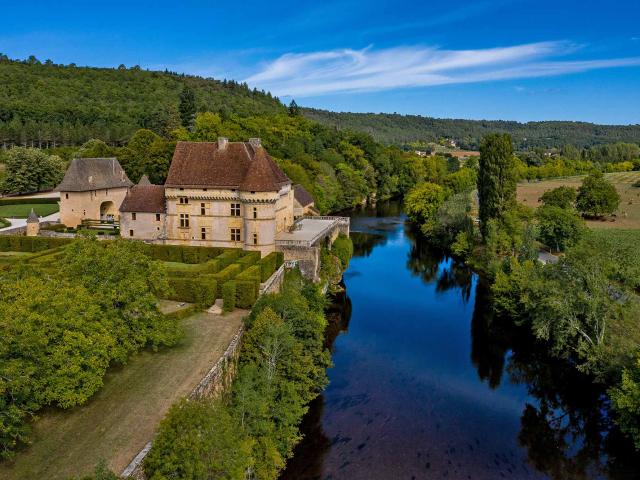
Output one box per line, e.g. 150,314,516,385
471,281,640,480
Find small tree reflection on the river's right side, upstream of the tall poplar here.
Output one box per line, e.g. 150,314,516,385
404,224,474,302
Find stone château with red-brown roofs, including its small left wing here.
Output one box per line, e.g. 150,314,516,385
120,138,294,254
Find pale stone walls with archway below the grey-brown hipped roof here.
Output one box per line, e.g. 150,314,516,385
60,187,129,228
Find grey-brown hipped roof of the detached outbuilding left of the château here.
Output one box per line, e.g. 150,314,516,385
56,158,133,192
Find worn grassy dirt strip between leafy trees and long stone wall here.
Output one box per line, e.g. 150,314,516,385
0,310,247,480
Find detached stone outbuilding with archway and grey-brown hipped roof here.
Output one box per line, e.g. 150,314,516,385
56,158,133,228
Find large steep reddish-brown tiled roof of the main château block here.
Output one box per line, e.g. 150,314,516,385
165,142,291,192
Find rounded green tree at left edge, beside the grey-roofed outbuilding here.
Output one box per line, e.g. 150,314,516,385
1,147,64,193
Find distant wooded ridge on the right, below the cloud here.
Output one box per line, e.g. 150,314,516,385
303,108,640,150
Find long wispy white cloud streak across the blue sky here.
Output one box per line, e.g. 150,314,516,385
246,42,640,97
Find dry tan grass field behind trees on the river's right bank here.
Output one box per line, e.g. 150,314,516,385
518,172,640,229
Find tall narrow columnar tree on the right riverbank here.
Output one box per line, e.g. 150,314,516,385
478,133,516,236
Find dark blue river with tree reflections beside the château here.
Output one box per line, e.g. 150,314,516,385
282,202,640,480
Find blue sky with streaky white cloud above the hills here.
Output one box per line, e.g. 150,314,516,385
0,0,640,124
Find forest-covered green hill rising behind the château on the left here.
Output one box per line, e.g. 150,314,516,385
0,54,285,146
